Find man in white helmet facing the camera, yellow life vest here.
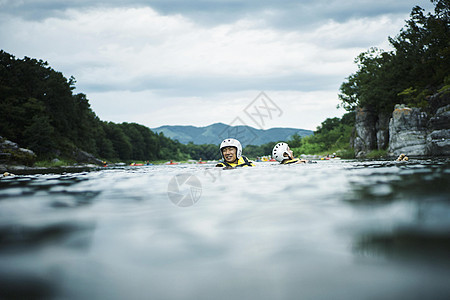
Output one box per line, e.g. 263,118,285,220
216,138,254,168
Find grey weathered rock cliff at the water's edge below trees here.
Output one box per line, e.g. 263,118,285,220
353,93,450,158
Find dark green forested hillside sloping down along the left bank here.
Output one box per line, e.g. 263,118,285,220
0,51,202,160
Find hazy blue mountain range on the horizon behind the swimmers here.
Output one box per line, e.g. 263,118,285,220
152,123,313,147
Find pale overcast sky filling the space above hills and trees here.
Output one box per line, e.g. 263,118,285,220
0,0,433,130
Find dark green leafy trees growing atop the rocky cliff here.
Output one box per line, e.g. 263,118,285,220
339,0,450,112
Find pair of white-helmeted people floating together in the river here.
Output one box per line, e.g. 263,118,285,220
216,138,307,168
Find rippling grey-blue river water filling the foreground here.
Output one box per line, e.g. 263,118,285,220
0,159,450,299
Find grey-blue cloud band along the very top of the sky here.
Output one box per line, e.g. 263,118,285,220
0,0,433,29
